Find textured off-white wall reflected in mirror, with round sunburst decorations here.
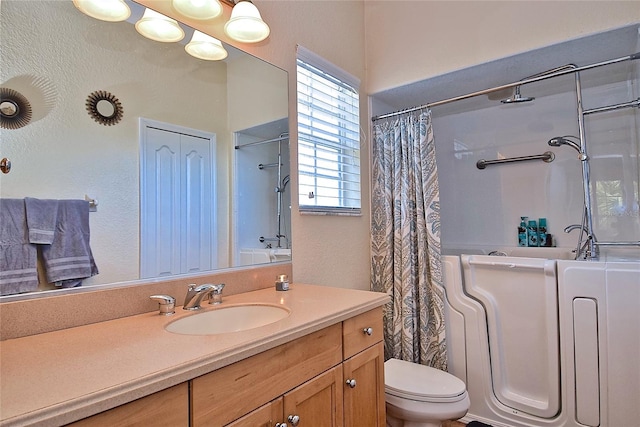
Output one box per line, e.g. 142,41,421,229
0,0,288,285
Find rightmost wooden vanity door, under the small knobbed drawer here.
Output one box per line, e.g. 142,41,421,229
343,342,386,427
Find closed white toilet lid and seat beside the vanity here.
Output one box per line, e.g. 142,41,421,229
384,359,466,402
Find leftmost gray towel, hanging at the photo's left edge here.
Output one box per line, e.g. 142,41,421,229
0,199,38,295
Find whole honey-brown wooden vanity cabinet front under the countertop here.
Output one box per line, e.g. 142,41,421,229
71,308,386,427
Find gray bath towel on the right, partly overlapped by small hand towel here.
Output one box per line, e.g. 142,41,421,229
42,200,98,288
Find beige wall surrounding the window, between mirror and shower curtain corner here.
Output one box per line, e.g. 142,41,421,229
239,0,370,289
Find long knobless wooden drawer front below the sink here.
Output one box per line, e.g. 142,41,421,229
191,324,342,427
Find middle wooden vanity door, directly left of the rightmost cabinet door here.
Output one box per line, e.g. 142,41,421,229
284,366,342,427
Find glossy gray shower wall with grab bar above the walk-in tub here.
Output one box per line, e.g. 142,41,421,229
434,61,640,256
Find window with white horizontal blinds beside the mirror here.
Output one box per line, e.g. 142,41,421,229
297,46,360,214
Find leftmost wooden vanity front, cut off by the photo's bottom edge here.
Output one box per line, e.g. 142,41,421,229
68,383,189,427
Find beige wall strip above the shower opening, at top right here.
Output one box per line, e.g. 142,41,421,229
365,0,640,93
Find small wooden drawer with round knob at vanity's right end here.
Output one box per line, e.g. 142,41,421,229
342,307,382,359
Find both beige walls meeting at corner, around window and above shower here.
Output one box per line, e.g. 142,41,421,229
222,0,640,289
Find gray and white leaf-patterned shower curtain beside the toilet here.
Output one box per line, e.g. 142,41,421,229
371,111,447,370
